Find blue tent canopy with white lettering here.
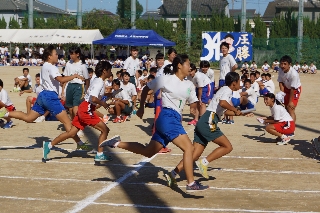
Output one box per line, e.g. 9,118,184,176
92,29,176,47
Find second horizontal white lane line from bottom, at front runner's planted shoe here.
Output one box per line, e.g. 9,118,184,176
0,176,320,193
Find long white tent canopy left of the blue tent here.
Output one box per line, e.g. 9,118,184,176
0,29,103,44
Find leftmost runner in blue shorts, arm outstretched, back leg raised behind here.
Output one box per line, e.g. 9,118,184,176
0,45,89,149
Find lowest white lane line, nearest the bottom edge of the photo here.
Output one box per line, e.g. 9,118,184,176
0,196,320,213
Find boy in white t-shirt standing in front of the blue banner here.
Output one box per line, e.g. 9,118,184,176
219,42,238,88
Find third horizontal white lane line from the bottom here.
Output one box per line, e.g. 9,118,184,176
0,158,320,175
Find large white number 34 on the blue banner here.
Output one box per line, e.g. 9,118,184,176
200,32,220,61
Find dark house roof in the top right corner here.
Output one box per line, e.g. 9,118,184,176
262,0,320,21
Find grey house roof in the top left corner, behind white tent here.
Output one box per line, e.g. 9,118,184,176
0,0,68,14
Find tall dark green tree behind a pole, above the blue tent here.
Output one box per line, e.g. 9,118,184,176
117,0,143,20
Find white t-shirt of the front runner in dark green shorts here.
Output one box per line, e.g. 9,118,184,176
207,86,232,118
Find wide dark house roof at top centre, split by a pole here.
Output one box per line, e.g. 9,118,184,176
159,0,228,16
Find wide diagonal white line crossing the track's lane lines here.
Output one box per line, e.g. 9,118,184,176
67,155,157,213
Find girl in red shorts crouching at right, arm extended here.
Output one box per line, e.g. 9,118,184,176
257,93,296,145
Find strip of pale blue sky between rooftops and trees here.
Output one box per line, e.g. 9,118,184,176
39,0,272,15
